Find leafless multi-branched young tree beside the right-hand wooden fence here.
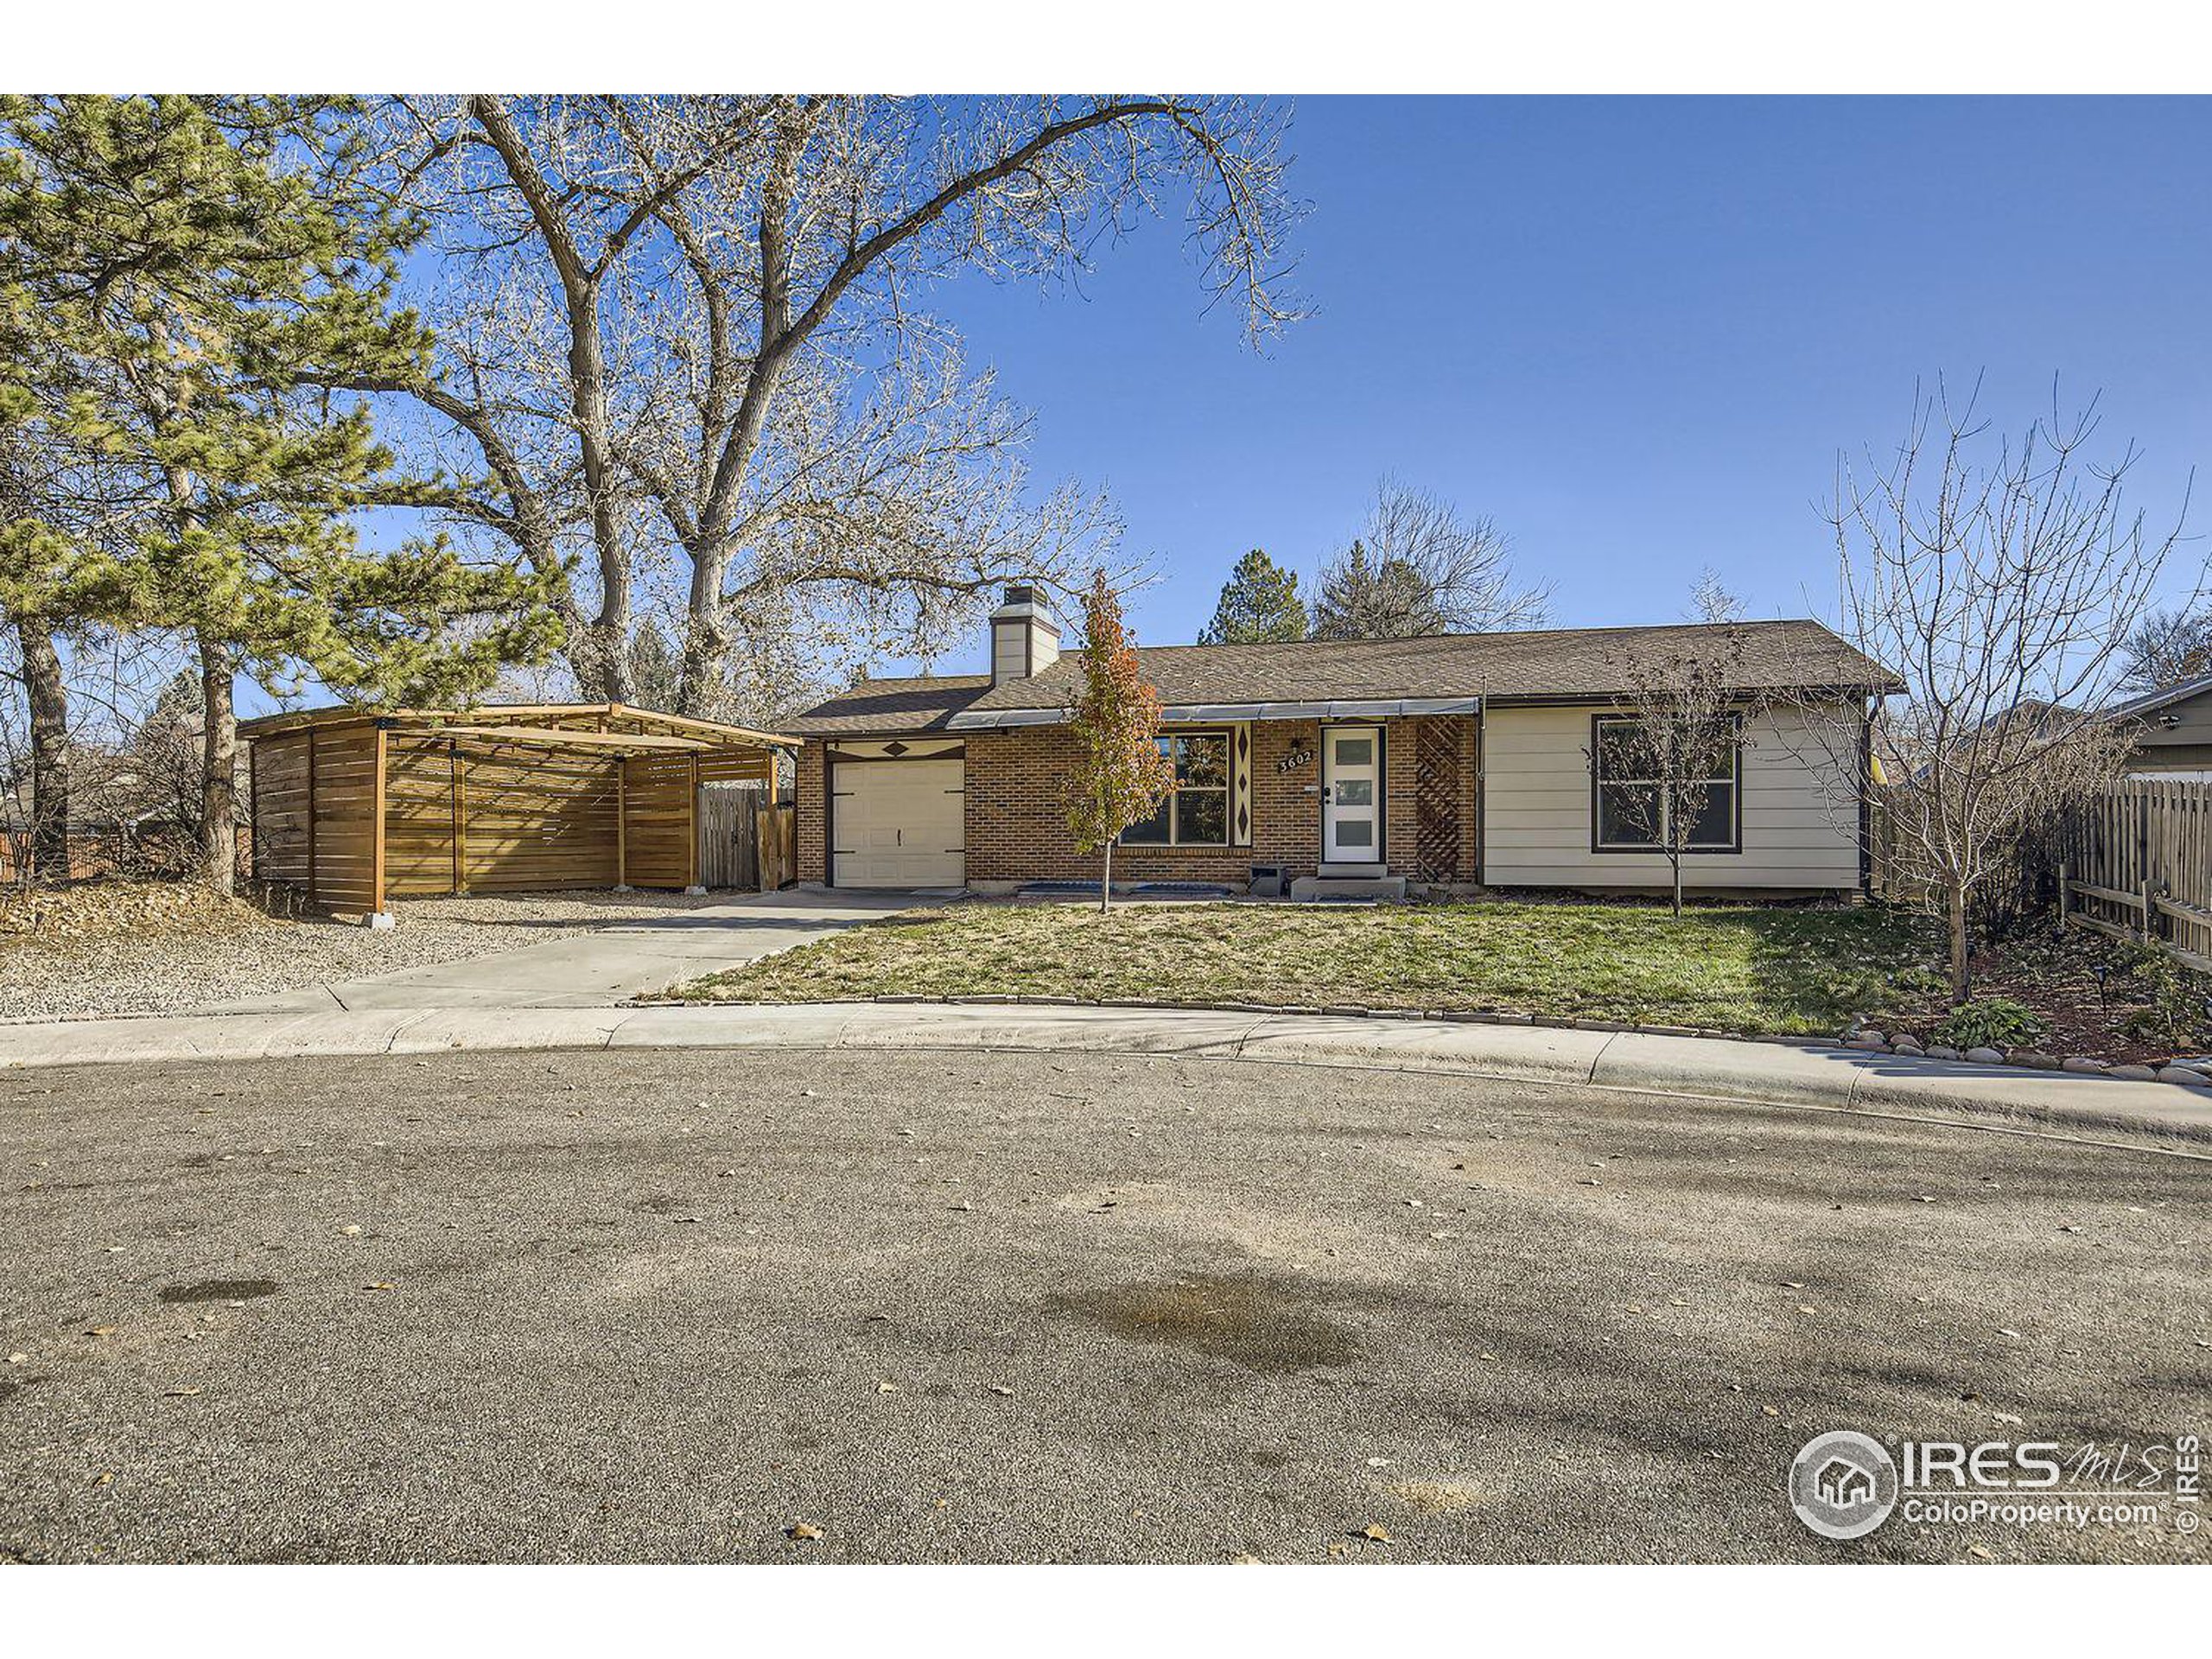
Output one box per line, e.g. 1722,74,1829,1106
1802,383,2205,1002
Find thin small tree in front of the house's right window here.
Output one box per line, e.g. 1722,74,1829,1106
1591,624,1763,916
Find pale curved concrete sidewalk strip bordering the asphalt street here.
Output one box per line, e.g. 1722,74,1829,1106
0,1002,2212,1144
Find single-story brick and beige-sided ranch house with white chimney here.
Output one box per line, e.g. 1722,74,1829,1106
787,586,1896,896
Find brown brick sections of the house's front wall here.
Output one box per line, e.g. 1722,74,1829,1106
797,715,1478,887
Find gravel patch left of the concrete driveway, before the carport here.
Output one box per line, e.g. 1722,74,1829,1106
0,892,730,1020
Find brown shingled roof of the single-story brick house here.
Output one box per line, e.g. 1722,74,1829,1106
790,620,1897,736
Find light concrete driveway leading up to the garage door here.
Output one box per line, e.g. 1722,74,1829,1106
201,889,943,1013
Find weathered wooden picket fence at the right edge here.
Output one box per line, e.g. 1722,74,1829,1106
2057,779,2212,971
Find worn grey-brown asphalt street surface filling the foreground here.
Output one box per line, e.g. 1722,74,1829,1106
0,1051,2212,1564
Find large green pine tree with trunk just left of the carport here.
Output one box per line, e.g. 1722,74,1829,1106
0,98,557,892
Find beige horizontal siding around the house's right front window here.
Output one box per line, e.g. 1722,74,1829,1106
1482,706,1858,889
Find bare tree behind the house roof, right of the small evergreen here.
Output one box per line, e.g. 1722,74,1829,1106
1314,478,1551,639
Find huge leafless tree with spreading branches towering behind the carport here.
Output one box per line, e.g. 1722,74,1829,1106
342,95,1296,716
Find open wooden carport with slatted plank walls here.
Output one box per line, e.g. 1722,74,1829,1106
238,703,797,918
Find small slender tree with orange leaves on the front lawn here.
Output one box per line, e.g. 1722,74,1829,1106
1066,570,1174,912
